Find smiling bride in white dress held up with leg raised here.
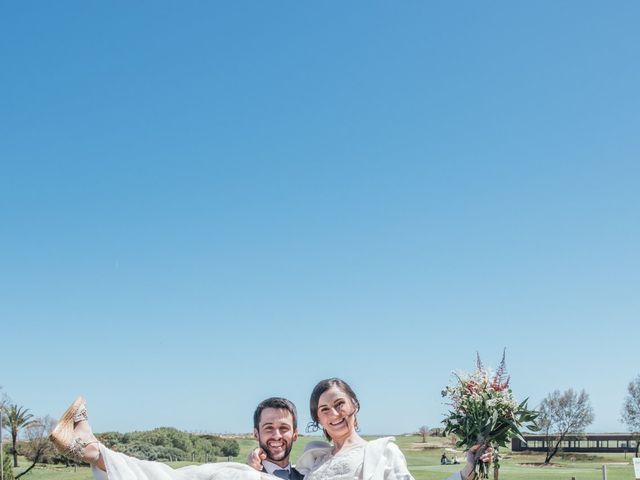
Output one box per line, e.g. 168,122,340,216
51,378,492,480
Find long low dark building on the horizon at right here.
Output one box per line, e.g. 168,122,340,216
511,433,638,453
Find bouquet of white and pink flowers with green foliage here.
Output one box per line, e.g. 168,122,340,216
442,351,539,479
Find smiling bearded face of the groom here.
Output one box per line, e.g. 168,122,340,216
253,408,298,467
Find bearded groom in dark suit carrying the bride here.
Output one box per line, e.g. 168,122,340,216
248,397,304,480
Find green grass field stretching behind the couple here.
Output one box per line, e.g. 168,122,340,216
8,436,634,480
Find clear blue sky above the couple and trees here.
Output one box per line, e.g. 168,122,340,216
0,0,640,434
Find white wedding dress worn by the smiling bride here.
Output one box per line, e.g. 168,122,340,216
92,437,460,480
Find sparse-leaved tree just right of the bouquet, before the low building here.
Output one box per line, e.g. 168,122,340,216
539,388,594,464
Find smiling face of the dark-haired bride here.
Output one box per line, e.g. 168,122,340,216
318,385,356,441
